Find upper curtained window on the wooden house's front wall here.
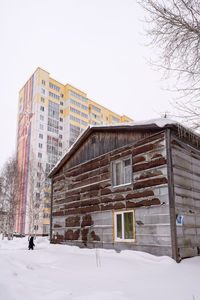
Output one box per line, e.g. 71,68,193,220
112,158,132,186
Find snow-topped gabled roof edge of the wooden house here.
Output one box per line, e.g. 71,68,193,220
48,118,194,178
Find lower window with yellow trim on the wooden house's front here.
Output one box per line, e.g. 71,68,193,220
113,210,135,242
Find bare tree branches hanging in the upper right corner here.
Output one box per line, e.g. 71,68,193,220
138,0,200,129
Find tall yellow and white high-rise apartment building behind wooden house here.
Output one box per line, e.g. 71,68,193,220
16,68,132,234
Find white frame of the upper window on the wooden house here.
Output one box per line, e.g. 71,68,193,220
111,156,133,188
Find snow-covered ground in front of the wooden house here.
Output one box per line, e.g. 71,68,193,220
0,238,200,300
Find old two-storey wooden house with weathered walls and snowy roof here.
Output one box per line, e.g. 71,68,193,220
49,119,200,261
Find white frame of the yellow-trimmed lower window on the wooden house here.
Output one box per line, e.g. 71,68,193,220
113,209,136,243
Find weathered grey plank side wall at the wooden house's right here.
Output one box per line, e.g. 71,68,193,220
172,134,200,257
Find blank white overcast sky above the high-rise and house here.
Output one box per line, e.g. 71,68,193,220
0,0,172,167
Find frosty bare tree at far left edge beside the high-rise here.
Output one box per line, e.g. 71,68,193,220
1,156,18,238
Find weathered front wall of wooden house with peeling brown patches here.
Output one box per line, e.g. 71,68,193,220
52,132,171,256
